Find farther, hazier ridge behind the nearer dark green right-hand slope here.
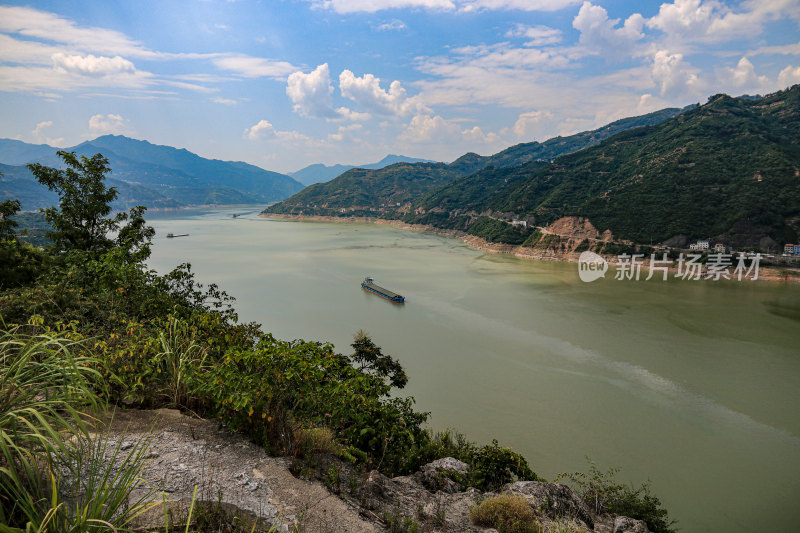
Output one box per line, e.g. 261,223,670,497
264,108,682,216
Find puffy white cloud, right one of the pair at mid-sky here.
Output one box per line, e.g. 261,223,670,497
339,70,423,116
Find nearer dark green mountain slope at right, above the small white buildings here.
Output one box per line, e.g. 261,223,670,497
406,86,800,247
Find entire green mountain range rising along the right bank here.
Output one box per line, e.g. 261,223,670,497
266,85,800,250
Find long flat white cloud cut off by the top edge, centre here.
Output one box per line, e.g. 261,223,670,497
308,0,580,13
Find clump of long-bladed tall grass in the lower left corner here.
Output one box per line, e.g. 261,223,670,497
0,327,158,533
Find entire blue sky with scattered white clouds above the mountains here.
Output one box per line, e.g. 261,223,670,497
0,0,800,172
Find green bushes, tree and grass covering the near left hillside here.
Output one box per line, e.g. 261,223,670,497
0,152,668,532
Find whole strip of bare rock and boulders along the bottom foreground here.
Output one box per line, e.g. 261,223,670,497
97,409,648,533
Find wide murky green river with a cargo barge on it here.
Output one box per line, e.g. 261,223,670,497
149,208,800,532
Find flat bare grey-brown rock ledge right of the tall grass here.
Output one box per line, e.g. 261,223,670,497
101,409,383,533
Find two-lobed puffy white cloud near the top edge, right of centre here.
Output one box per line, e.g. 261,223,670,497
572,2,645,56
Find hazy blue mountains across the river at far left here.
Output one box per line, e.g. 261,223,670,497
0,135,303,210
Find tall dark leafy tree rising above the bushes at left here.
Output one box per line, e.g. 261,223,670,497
28,151,155,263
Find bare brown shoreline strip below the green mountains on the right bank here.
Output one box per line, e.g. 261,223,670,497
258,213,800,283
